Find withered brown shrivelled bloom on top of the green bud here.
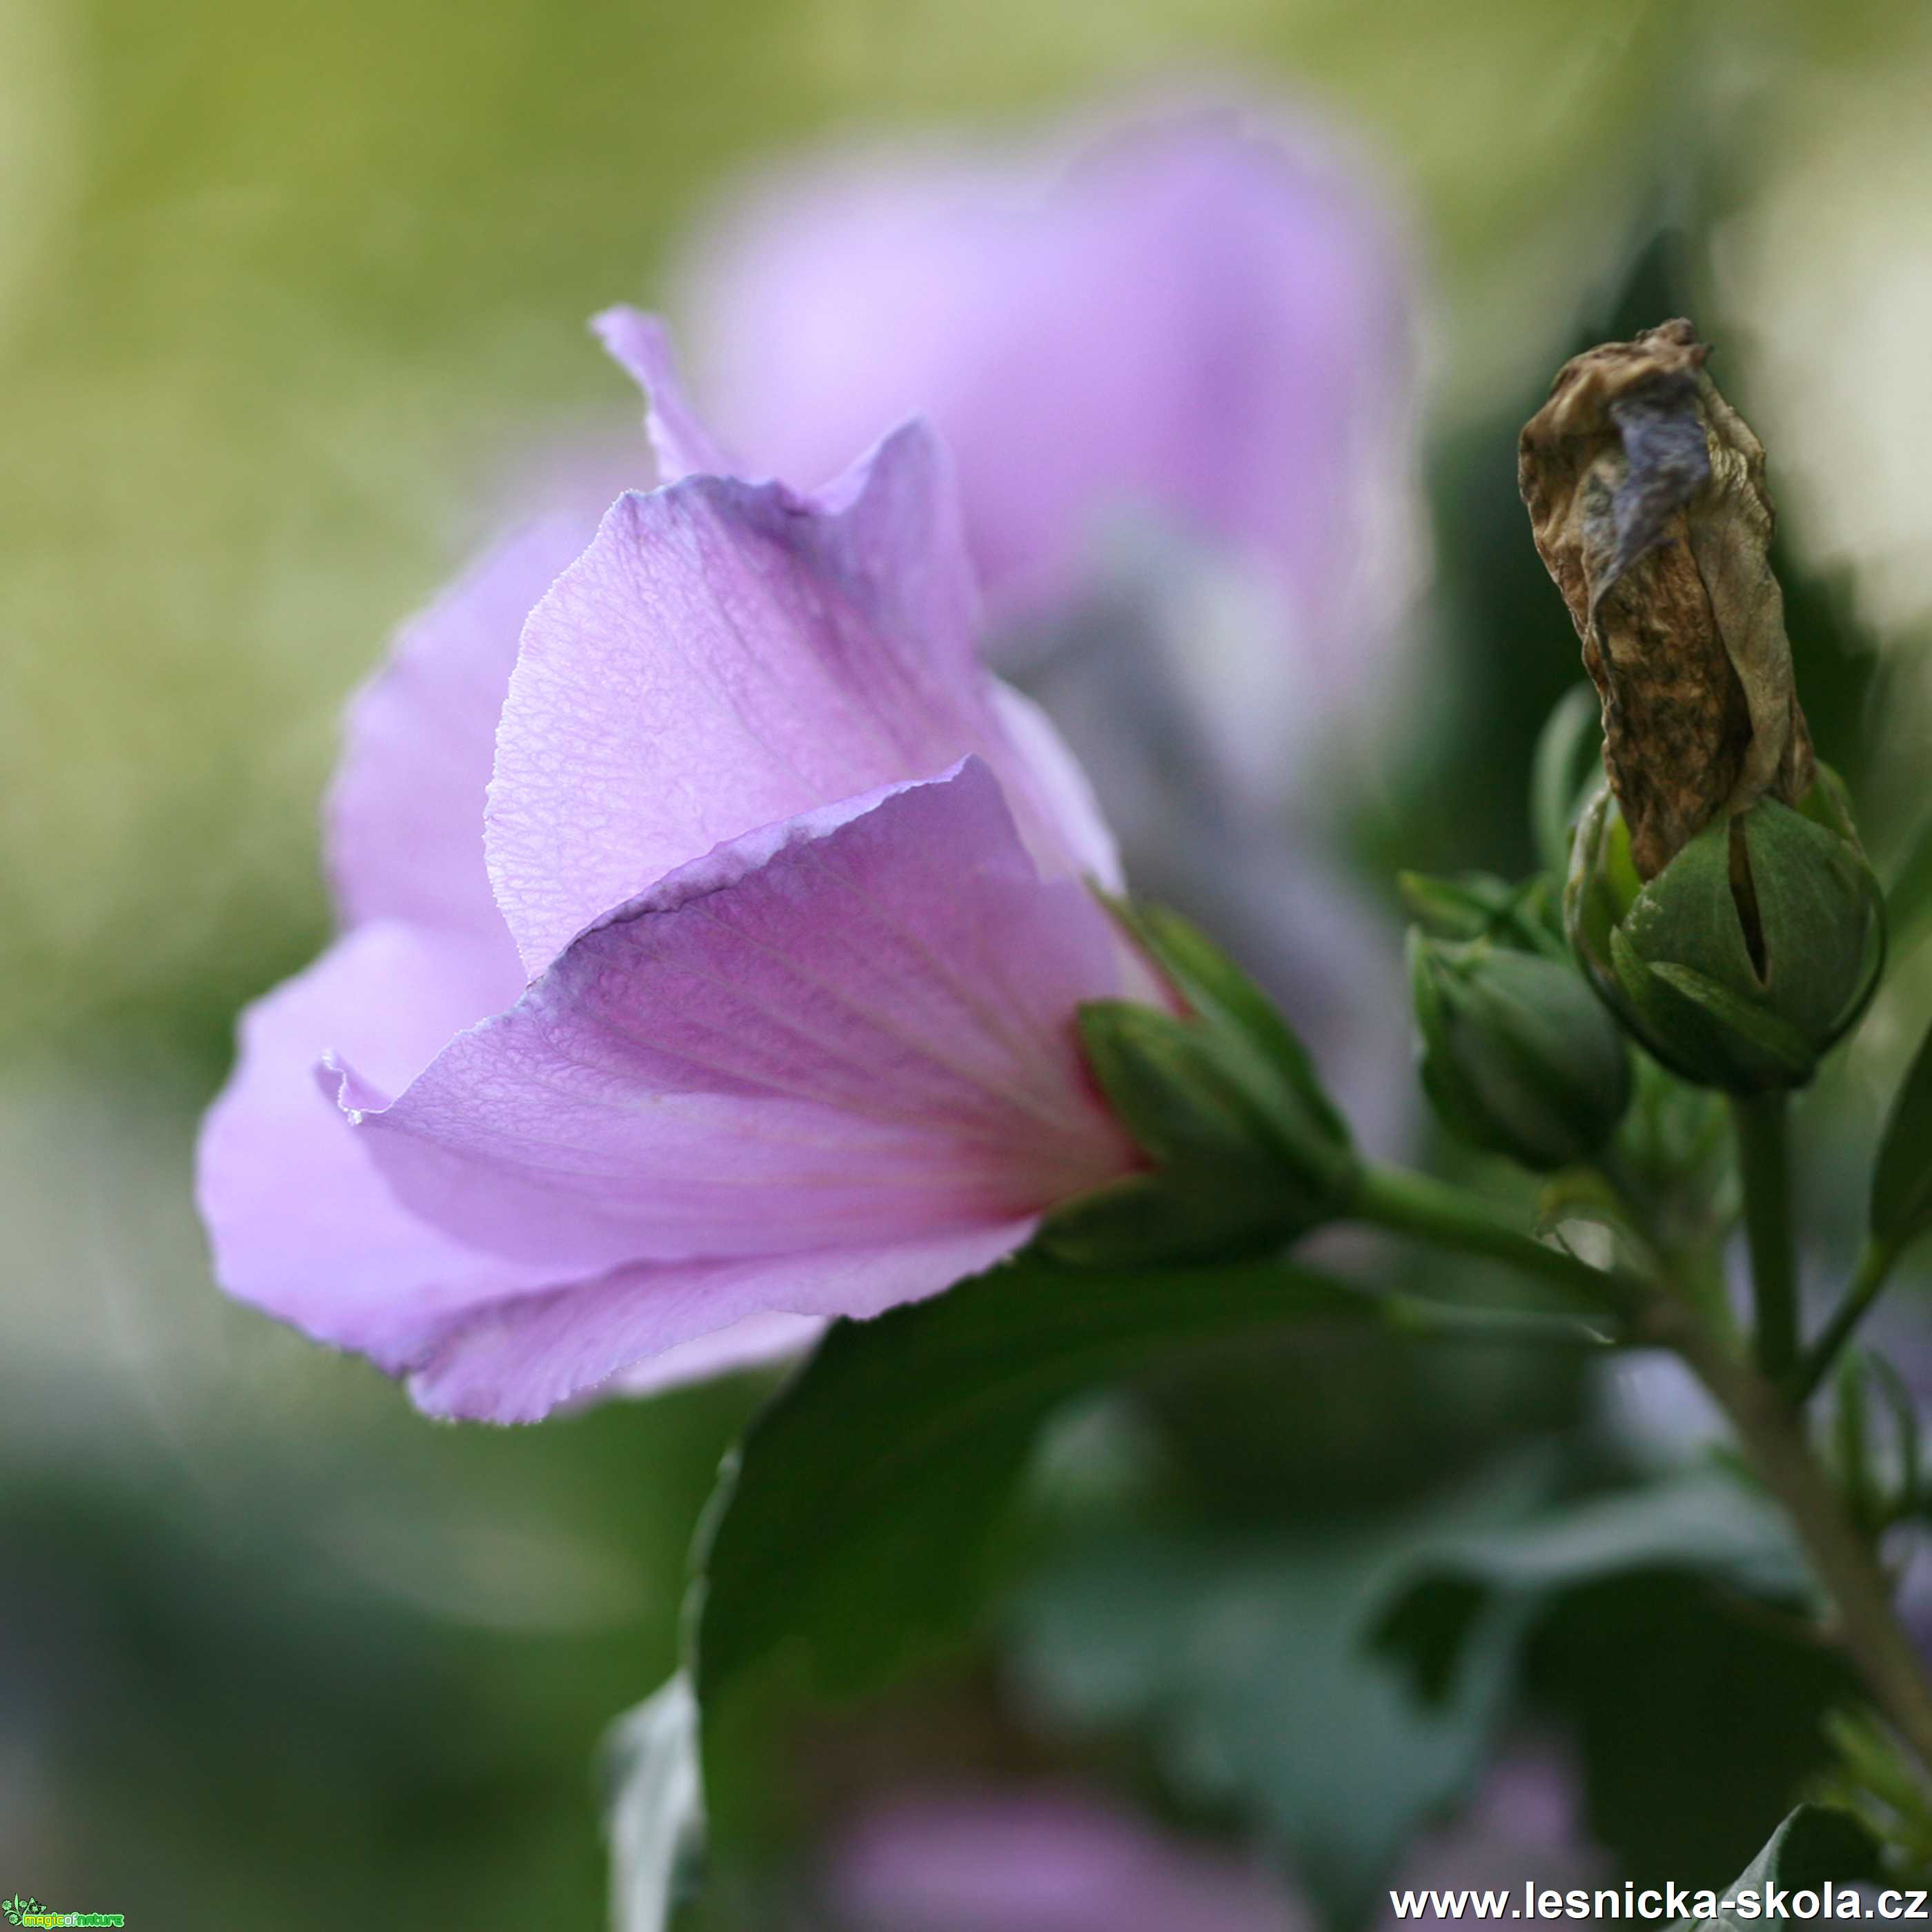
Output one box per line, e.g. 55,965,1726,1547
1517,321,1814,879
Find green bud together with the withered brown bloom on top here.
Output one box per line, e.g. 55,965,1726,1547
1519,321,1886,1094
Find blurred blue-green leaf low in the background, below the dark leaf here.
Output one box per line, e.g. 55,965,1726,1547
1012,1468,1544,1926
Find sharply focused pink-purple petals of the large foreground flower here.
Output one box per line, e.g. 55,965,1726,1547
201,328,1150,1420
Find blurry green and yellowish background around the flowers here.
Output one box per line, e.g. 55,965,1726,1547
11,0,1932,1928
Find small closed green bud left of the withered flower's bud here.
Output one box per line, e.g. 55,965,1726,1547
1408,931,1630,1173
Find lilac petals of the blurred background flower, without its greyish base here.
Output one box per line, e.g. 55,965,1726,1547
690,108,1412,726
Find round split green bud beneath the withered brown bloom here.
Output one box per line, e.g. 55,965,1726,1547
1563,767,1886,1094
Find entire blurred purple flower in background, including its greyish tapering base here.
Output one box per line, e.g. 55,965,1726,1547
684,104,1424,1152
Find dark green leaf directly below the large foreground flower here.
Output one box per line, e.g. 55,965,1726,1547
696,1250,1381,1731
